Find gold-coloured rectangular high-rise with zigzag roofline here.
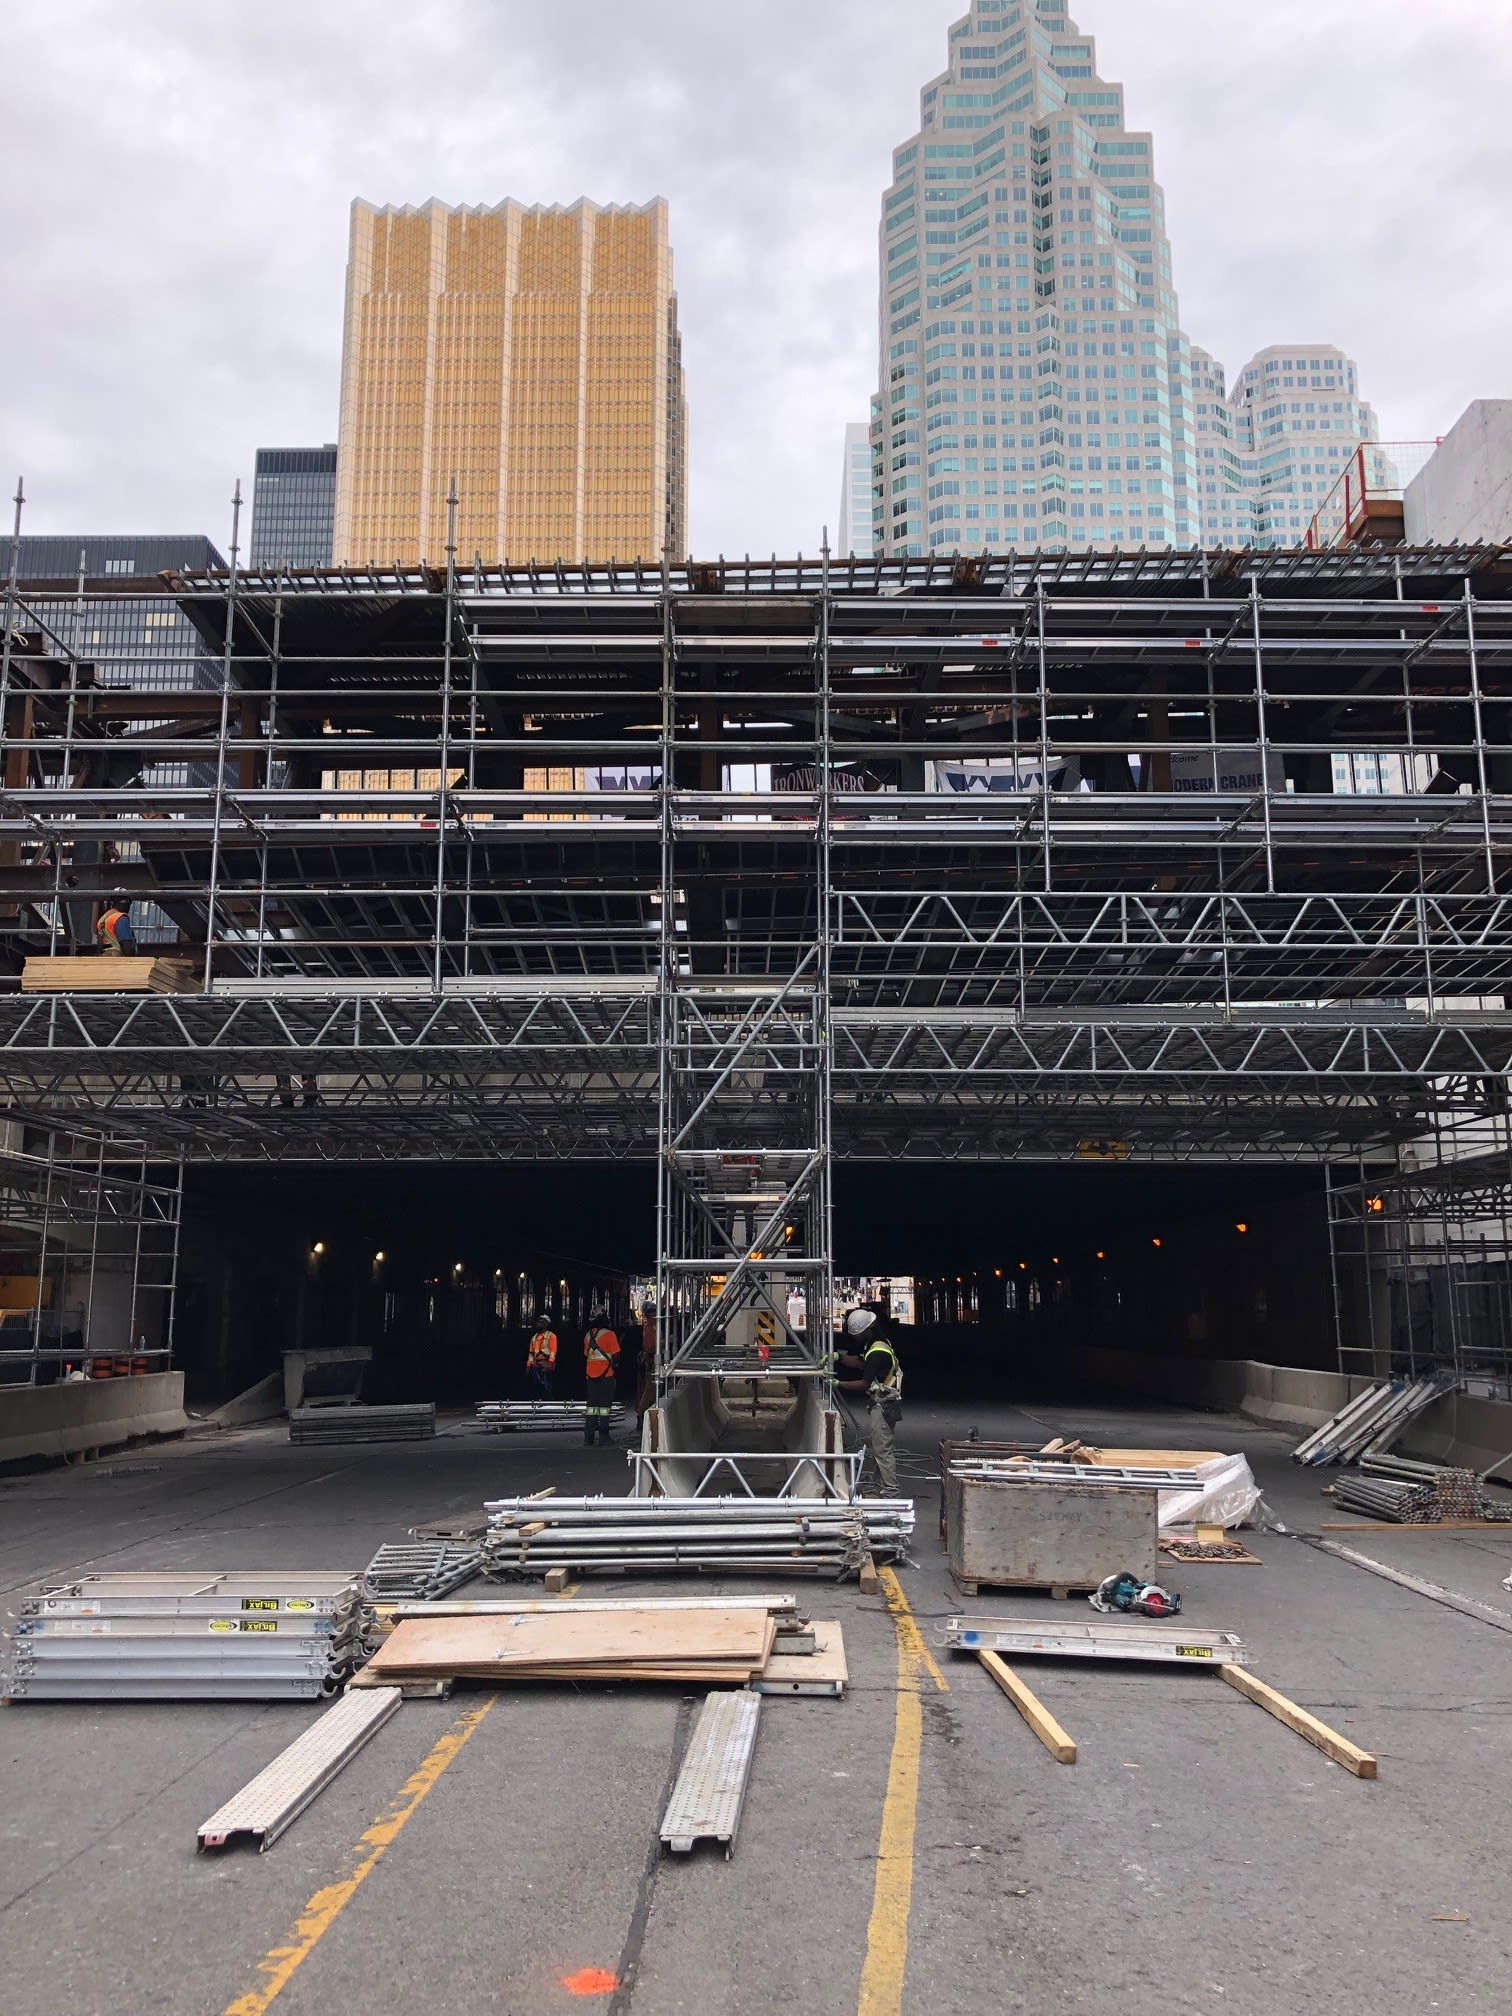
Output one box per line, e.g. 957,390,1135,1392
335,198,687,564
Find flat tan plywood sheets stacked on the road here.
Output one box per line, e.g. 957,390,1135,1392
355,1603,776,1687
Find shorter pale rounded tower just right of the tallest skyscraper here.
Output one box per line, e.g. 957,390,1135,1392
1191,343,1381,546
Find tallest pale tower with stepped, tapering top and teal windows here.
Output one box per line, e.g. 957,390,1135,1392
873,0,1198,554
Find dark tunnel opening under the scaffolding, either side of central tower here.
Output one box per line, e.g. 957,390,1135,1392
177,1163,1335,1407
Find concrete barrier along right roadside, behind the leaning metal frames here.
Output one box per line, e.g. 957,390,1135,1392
1062,1349,1512,1470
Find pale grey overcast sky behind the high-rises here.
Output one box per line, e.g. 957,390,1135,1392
0,0,1512,552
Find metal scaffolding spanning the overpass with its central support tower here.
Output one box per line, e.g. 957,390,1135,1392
0,520,1512,1397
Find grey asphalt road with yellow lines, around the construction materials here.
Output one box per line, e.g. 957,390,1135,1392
0,1403,1512,2016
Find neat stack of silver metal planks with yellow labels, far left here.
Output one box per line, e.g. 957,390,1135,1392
0,1568,375,1702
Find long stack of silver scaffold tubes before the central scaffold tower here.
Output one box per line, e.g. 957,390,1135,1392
482,1498,913,1581
